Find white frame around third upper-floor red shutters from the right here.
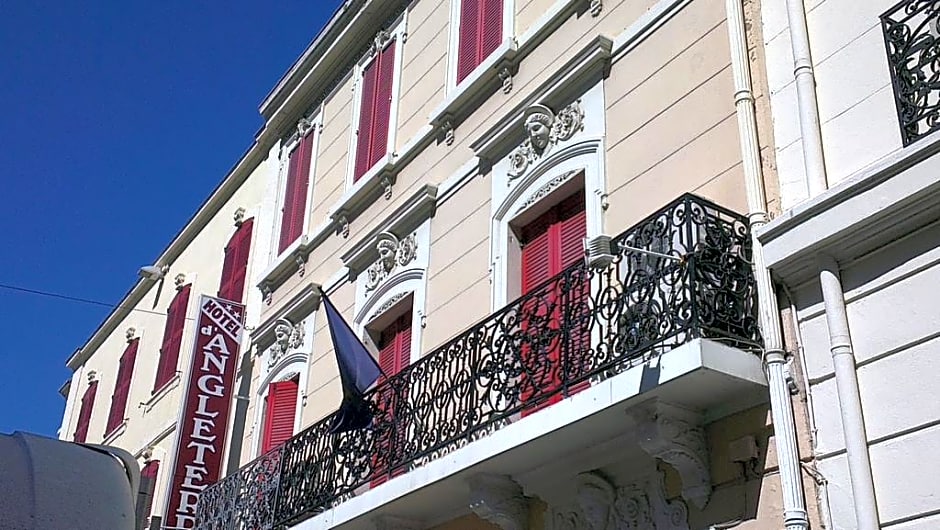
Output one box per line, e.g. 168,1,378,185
272,111,323,261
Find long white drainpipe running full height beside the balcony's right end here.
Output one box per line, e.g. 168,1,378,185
726,0,809,530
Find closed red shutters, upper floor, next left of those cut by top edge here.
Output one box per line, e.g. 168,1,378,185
353,38,397,182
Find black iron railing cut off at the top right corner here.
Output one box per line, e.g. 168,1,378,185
881,0,940,145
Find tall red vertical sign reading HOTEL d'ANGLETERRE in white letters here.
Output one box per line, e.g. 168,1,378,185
163,295,245,528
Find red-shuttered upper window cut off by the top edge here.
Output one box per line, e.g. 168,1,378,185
457,0,503,84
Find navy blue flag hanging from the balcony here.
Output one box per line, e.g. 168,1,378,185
322,293,382,433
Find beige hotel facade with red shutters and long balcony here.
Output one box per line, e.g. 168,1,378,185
62,0,832,530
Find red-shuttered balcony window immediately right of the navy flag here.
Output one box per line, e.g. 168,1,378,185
372,307,411,487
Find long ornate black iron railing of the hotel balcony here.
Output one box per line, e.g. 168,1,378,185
197,195,760,530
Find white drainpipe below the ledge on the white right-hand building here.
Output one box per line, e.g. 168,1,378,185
818,256,881,530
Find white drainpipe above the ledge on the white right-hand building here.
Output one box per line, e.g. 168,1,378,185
787,0,829,198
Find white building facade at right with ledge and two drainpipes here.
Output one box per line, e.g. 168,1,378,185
758,0,940,529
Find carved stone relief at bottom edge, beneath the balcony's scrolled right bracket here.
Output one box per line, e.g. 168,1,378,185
551,472,689,530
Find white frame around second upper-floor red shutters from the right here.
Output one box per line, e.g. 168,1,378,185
345,10,408,190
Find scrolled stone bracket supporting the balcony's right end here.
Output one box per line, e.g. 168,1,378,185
629,402,712,509
